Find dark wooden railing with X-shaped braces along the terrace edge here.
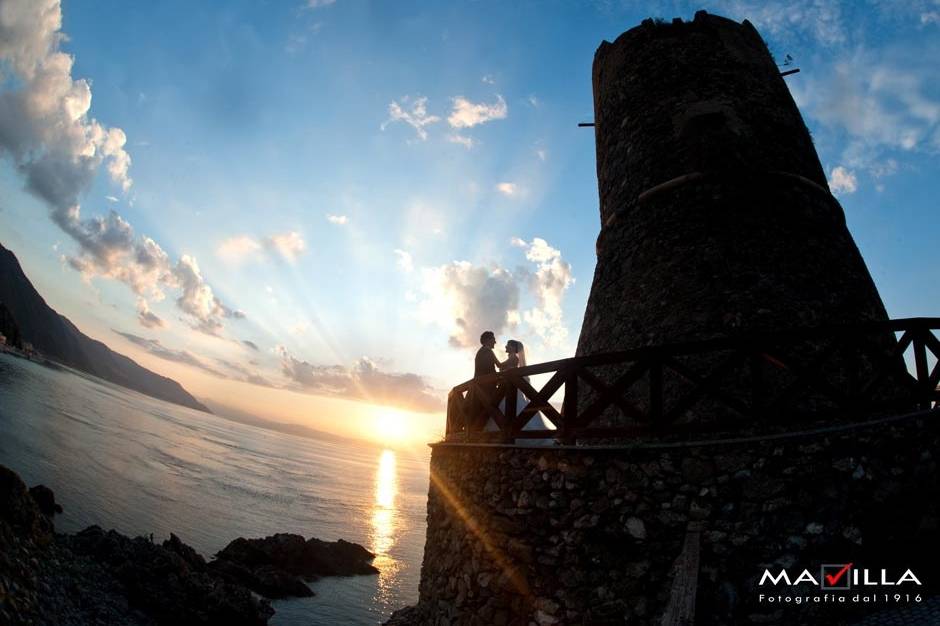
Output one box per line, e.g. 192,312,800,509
446,318,940,443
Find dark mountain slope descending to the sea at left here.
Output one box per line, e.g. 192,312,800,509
0,245,212,413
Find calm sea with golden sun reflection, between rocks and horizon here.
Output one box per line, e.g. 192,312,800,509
0,354,430,626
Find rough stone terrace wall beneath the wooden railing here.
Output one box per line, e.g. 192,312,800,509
412,415,940,625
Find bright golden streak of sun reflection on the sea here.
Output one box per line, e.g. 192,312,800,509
371,450,400,603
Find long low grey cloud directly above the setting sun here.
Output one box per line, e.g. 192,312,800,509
276,346,443,412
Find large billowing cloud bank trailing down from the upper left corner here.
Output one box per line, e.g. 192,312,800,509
0,0,241,336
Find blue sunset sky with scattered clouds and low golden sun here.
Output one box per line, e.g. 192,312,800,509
0,0,940,439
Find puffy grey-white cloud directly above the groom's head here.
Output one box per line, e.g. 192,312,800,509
421,261,519,348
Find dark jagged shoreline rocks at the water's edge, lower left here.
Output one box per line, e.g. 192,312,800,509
0,465,378,626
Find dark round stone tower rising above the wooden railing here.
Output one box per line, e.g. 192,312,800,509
577,11,890,420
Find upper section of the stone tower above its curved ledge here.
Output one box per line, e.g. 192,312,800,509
593,11,826,224
